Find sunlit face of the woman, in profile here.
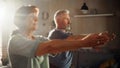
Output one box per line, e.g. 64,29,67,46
25,12,38,31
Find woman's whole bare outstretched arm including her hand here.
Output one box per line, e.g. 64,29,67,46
36,34,106,56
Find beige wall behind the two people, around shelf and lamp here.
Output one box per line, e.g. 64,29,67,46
32,0,114,36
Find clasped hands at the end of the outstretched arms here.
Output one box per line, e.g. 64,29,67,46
82,32,115,47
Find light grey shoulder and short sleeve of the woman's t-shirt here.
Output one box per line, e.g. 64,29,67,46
9,35,48,57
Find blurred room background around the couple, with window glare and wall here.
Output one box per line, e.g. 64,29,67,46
0,0,120,68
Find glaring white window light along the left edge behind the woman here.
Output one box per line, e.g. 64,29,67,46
0,0,15,59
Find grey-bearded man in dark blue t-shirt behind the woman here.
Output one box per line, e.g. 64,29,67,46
48,10,114,68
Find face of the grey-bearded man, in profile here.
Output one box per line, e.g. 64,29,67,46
57,13,70,29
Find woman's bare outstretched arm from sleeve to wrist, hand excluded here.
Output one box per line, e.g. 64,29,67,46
36,40,82,56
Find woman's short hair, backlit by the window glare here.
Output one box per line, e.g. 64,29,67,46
14,5,39,28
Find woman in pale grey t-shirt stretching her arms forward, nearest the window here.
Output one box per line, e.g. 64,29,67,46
8,6,113,68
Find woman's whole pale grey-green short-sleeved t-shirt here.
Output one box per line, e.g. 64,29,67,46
8,33,49,68
